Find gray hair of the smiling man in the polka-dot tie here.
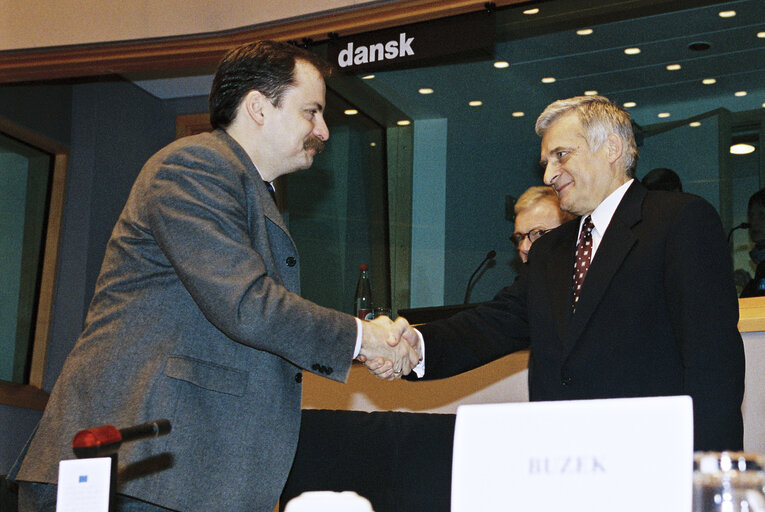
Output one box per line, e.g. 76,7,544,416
535,96,638,178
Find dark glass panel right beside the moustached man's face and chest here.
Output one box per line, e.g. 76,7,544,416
282,86,390,313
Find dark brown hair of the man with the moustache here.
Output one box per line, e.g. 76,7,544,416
209,41,330,128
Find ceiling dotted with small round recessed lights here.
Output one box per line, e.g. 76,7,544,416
128,0,765,126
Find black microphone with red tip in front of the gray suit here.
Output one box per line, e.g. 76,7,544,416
72,420,171,459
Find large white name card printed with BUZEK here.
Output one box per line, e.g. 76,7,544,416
451,396,693,512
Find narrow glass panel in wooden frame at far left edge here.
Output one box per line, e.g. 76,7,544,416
0,134,53,383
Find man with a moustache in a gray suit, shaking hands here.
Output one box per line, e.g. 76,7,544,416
11,41,418,512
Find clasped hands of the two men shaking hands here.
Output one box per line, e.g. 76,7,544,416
356,316,422,380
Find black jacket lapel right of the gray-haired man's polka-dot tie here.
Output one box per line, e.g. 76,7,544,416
564,182,646,352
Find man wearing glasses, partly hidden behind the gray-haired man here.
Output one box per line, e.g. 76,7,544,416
510,186,574,263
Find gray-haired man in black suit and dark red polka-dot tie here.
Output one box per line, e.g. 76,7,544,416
374,96,744,450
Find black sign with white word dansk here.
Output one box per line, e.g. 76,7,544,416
327,11,494,74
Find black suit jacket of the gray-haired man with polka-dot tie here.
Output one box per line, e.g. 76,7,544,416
414,182,744,450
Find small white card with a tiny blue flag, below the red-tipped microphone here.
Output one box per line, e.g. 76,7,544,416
56,457,112,512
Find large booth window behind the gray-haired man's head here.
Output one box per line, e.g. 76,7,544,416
312,0,765,307
